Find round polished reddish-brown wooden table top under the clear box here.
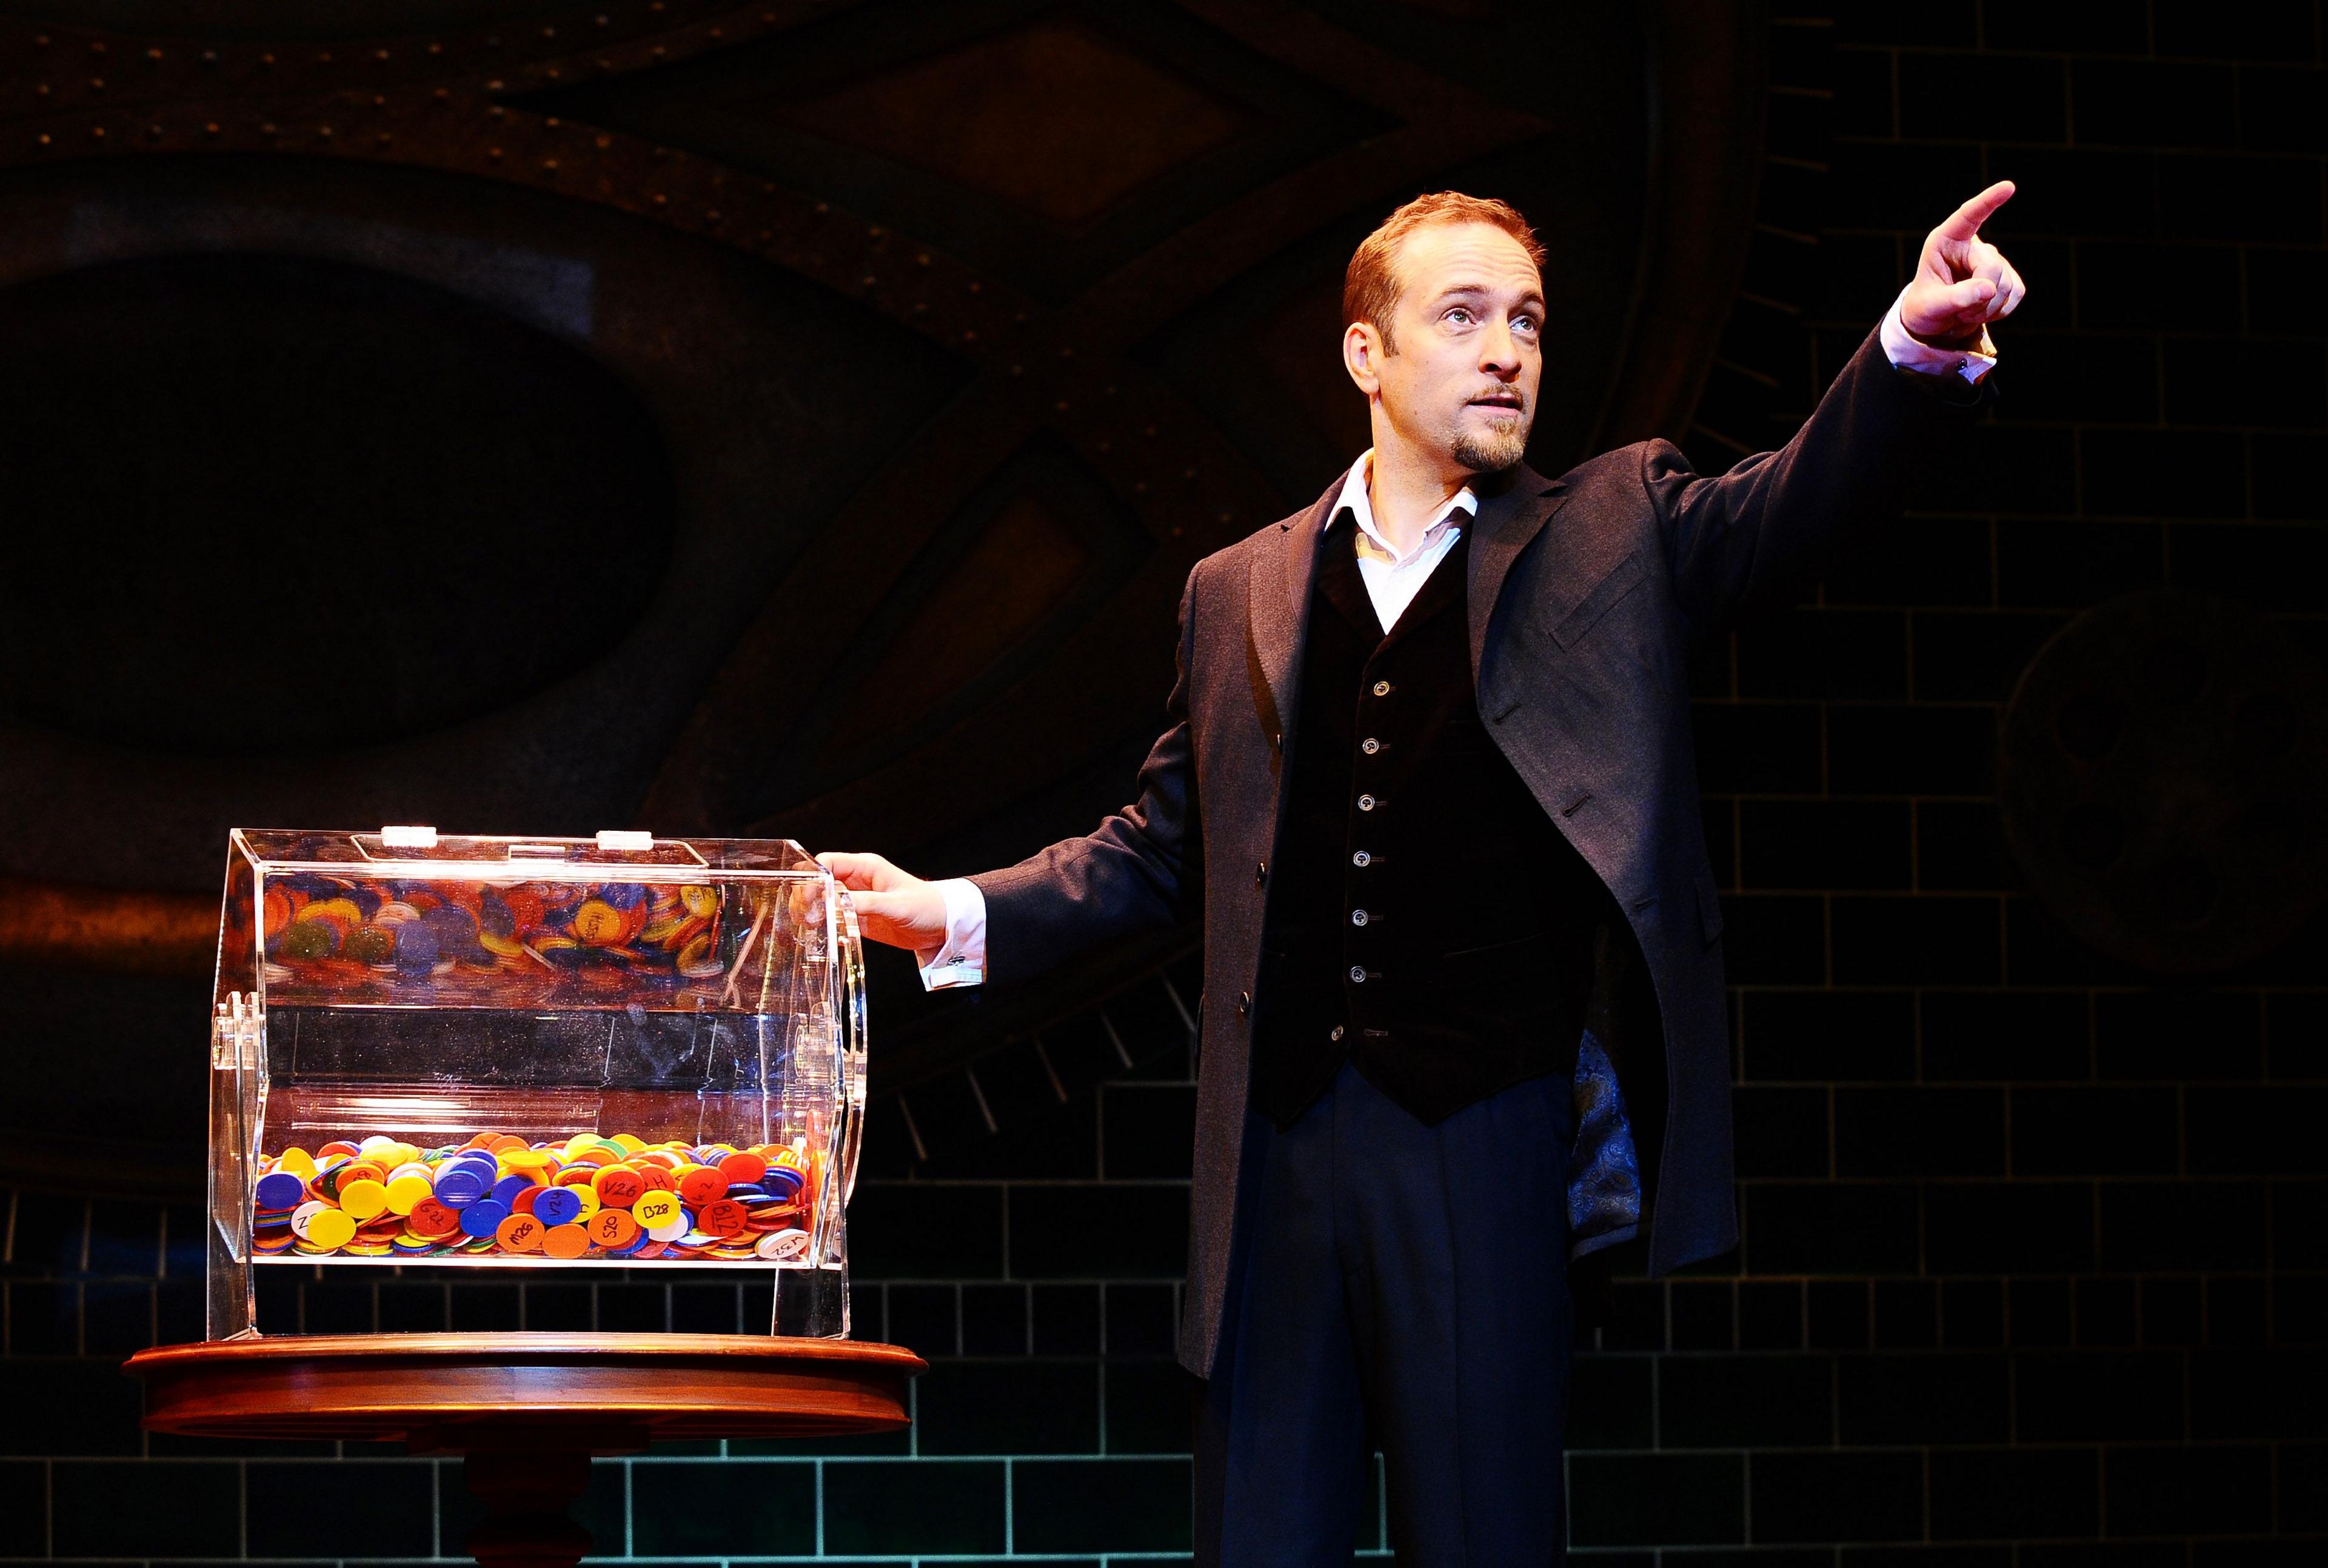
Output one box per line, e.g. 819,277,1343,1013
124,1333,926,1452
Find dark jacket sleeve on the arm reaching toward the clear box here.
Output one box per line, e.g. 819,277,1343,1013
971,568,1203,979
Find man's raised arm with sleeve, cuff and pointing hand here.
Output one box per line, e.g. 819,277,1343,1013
1641,181,2028,633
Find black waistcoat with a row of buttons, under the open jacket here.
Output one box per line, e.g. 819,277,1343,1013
1253,512,1616,1126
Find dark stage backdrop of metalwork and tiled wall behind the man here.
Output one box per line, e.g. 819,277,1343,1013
0,0,2328,1568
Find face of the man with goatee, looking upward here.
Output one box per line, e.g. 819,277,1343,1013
1374,223,1544,475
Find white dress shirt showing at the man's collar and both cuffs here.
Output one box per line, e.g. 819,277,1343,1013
915,289,1998,991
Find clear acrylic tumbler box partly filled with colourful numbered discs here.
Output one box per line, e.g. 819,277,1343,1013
207,828,866,1340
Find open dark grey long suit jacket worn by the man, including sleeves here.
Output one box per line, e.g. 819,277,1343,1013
973,335,1979,1377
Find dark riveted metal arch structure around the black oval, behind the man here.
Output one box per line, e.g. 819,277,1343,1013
0,0,1769,1186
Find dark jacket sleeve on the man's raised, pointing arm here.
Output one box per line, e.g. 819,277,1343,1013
1641,316,1993,635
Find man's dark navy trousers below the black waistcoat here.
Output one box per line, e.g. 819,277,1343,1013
1197,1066,1571,1568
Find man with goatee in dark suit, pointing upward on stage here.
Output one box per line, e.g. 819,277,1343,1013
822,184,2023,1568
